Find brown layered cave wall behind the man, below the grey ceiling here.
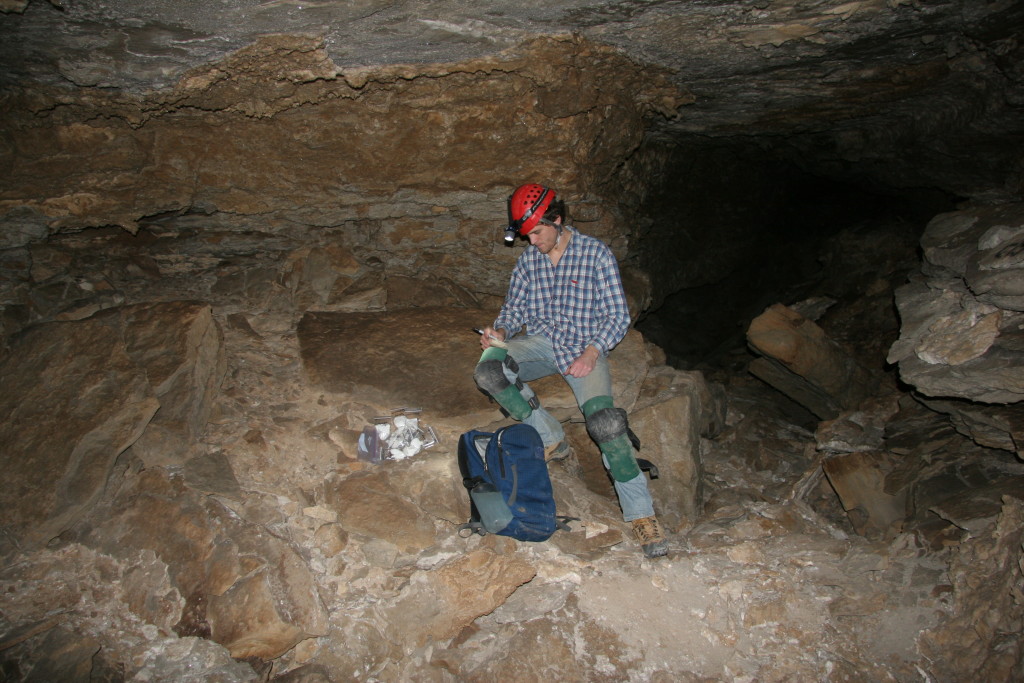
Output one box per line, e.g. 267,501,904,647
0,36,685,313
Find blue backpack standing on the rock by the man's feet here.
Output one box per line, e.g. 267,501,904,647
459,423,565,542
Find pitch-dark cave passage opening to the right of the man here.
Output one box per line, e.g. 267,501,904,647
632,139,959,368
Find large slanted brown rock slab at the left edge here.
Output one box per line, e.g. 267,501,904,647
0,302,224,546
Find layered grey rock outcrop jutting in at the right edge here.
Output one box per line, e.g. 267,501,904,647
889,204,1024,403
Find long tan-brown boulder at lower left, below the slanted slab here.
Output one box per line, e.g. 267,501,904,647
88,468,327,659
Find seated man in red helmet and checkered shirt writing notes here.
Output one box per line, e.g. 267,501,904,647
474,183,669,557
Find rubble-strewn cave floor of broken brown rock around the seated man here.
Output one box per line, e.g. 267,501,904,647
0,201,1021,681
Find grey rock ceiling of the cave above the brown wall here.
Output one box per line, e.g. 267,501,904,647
0,0,1024,201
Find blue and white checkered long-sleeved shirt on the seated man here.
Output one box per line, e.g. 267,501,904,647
494,225,630,374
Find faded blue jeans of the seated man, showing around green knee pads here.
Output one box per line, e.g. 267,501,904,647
497,335,654,521
